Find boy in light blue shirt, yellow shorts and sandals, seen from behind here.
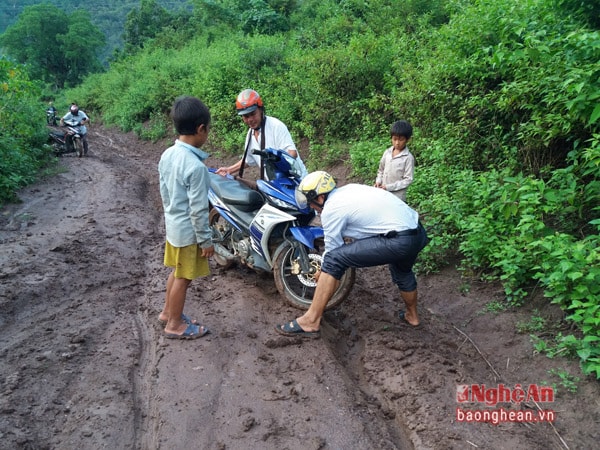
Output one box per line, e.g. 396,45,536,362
158,97,214,339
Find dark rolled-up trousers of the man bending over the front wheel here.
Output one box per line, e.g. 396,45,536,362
321,223,428,292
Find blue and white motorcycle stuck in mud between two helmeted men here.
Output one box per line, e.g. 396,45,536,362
208,149,356,309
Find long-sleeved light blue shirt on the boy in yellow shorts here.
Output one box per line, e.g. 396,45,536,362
158,140,212,248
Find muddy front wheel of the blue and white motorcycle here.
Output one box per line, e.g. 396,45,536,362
273,242,356,310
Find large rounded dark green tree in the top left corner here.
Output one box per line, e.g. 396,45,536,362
0,3,106,88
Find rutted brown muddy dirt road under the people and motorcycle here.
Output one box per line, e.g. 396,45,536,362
0,127,600,450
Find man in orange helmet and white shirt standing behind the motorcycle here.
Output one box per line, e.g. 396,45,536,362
217,89,307,180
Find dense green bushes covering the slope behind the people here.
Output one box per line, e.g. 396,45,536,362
1,0,600,378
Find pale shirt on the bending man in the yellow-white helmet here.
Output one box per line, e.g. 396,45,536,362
321,184,419,252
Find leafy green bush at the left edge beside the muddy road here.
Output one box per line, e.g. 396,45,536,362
0,59,50,205
